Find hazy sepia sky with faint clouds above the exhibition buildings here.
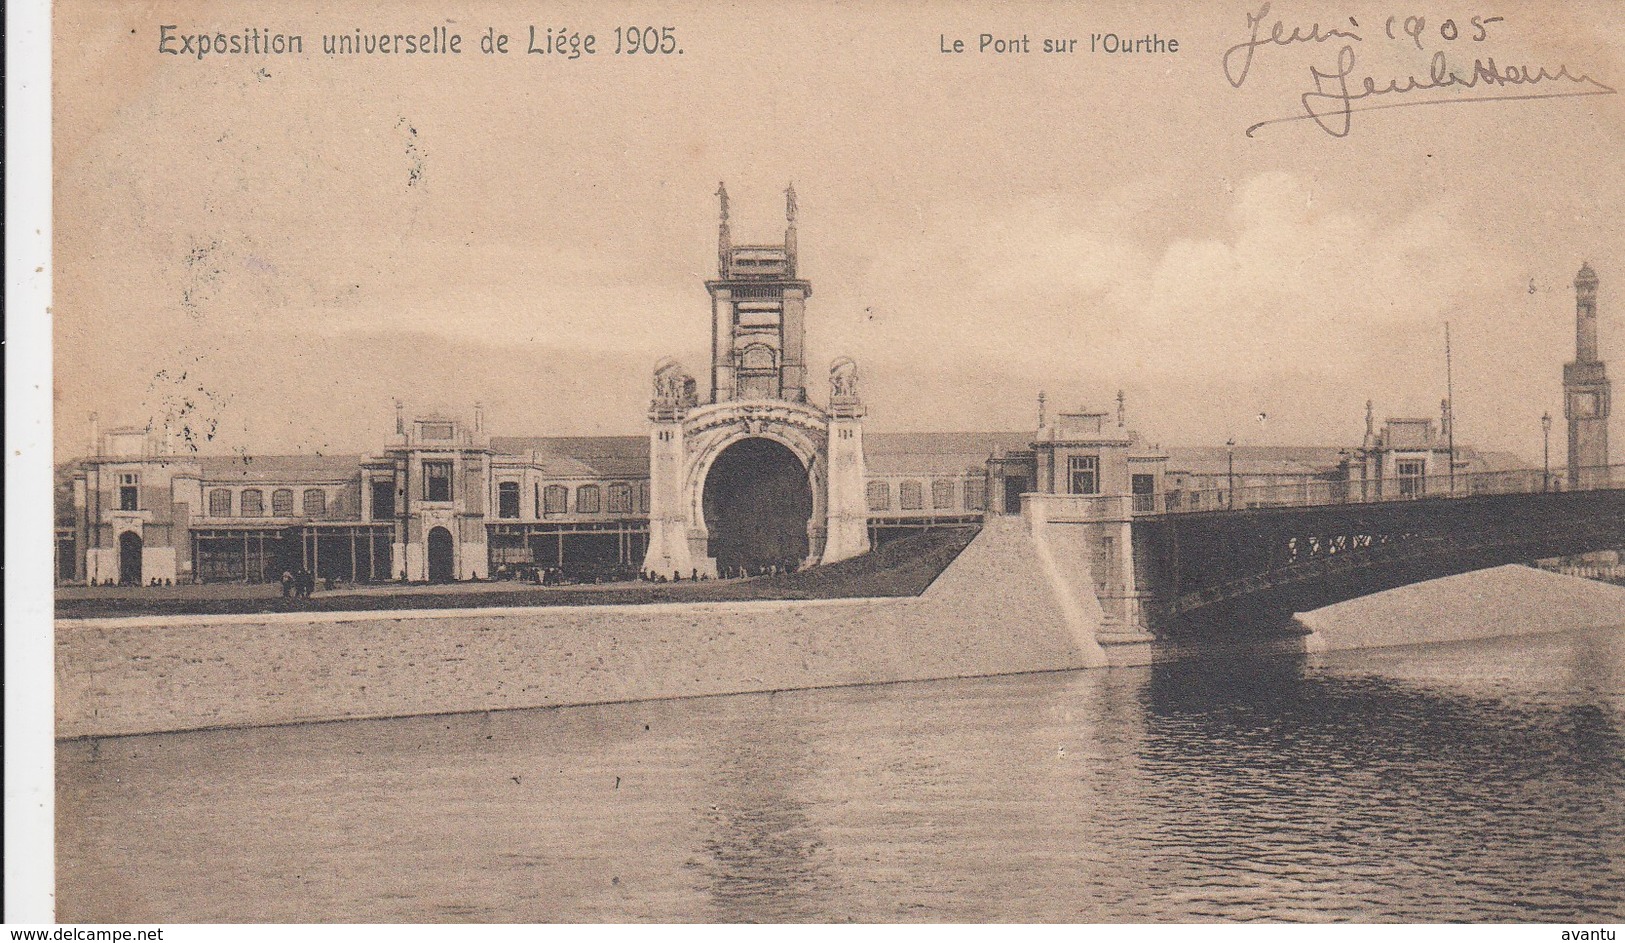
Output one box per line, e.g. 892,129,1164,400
52,0,1625,462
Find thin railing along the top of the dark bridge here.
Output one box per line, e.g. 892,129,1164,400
1157,465,1625,514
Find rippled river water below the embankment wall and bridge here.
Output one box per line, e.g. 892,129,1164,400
57,631,1625,922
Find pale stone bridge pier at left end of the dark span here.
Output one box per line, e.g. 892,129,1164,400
1022,494,1157,665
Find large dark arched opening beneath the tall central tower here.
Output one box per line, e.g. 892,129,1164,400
704,439,813,574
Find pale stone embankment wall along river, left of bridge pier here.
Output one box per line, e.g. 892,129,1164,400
57,519,1103,738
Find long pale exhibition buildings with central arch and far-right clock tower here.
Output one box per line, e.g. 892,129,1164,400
55,196,1579,584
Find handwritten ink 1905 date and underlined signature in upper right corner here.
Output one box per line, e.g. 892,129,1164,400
1224,3,1617,138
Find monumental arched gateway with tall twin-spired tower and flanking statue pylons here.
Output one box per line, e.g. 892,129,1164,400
644,187,869,579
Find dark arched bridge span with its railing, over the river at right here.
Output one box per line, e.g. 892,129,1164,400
1133,467,1625,631
